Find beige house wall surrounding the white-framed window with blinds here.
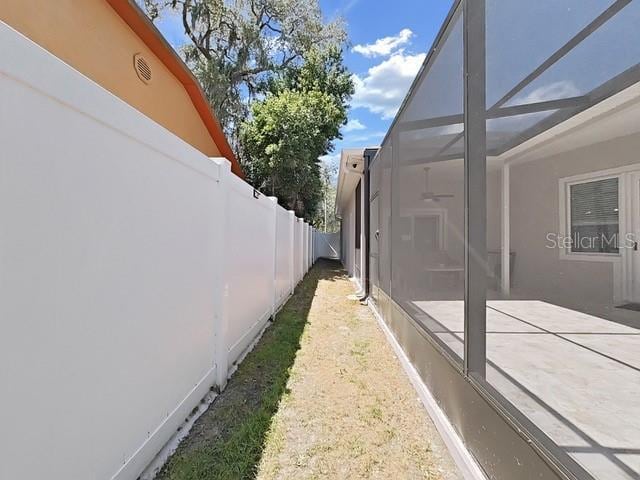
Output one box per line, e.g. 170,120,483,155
504,131,640,305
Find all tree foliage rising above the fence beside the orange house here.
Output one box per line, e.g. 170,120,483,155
138,0,353,220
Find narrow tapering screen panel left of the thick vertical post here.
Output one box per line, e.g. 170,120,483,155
382,5,464,361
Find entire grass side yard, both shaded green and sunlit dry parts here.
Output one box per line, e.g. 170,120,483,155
159,262,461,480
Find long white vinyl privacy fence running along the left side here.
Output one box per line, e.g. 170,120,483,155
0,22,310,480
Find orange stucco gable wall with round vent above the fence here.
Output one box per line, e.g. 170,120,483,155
0,0,220,156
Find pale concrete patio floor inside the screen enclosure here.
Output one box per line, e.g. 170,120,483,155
413,300,640,480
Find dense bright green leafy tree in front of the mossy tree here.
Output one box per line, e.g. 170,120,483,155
241,49,353,220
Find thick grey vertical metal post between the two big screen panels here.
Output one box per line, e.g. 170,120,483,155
464,0,487,379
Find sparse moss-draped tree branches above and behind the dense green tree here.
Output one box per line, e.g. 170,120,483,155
143,0,346,142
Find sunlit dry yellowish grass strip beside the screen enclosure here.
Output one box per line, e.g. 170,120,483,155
257,262,460,480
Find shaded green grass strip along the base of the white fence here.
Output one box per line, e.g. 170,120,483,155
156,260,345,480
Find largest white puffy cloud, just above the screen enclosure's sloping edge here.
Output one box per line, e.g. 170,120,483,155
351,52,425,119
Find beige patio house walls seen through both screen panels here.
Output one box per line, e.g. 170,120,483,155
376,130,640,305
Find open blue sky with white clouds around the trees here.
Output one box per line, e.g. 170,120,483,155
157,0,452,172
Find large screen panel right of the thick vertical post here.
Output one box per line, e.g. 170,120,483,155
484,0,640,480
